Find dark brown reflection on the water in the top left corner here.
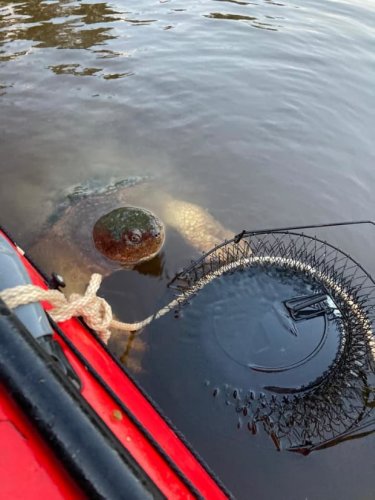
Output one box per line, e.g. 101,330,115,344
0,0,125,74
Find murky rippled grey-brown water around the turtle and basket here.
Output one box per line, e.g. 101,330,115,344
0,0,375,500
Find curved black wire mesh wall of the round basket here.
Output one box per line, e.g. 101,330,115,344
170,231,375,454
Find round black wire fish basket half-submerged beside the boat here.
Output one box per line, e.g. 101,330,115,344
170,221,375,454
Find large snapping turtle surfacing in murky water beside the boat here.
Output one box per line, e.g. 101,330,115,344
29,177,233,293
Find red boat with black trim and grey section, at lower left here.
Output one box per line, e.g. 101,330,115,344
0,229,230,499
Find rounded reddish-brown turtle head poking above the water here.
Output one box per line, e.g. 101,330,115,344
93,207,165,267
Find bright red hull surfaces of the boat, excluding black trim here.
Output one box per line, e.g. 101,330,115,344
0,228,228,499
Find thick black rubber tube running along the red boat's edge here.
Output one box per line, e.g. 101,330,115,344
0,301,164,500
